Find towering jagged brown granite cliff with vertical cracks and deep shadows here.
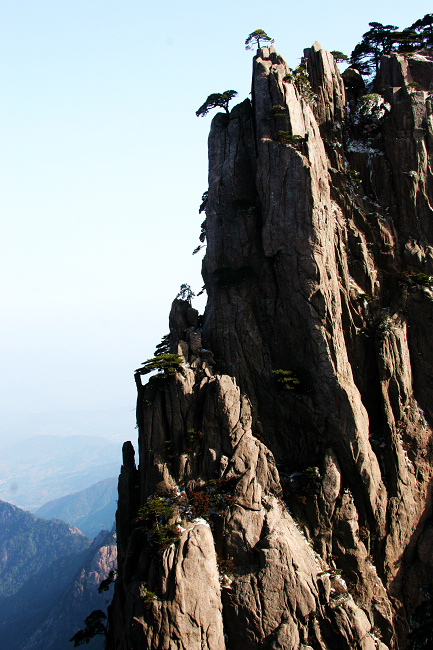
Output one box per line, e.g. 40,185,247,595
110,43,433,650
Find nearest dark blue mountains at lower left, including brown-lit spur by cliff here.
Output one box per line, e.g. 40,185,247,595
0,501,116,650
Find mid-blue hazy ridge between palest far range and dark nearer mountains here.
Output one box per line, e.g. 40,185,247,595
35,478,117,537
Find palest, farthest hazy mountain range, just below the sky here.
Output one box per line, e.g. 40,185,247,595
0,435,121,508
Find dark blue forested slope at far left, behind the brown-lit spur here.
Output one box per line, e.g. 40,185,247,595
0,501,91,650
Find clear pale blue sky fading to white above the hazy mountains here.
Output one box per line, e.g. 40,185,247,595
0,0,431,440
